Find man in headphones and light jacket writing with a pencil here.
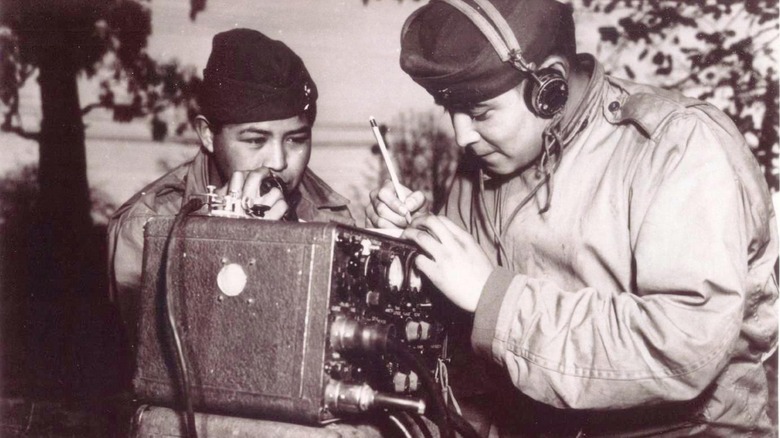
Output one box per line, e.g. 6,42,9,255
366,0,778,437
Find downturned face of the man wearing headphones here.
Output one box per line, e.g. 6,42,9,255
448,80,546,175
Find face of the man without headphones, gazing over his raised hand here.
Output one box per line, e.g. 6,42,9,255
213,116,311,190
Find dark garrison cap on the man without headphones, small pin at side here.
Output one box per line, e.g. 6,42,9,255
199,29,317,124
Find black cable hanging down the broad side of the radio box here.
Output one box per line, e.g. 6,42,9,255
165,198,204,438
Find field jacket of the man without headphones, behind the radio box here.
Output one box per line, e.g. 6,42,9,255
108,152,354,344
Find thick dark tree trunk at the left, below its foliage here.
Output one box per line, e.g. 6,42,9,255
28,50,94,395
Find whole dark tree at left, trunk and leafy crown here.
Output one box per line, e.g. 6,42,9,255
0,0,205,396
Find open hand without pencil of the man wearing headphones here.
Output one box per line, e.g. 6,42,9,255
401,215,493,312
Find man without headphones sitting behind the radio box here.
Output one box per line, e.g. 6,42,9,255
108,29,353,344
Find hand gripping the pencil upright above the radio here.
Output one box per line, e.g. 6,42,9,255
366,179,428,229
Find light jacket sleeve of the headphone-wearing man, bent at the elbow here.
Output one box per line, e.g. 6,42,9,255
472,111,768,409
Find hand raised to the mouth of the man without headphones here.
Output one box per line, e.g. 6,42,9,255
220,167,290,220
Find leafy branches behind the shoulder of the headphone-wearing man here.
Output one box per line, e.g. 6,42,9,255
574,0,778,190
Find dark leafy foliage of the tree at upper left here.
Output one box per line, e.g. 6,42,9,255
0,0,205,139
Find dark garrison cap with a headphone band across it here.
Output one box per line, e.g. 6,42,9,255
401,0,574,106
